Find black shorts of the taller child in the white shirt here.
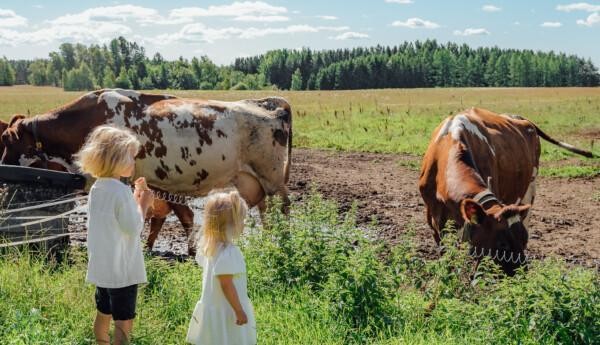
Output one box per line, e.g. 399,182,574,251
96,285,137,321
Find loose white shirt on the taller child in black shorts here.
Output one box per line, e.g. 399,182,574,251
86,178,147,289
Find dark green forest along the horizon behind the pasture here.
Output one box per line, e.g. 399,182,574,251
0,37,600,91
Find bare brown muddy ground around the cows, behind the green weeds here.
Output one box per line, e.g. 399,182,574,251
72,149,600,265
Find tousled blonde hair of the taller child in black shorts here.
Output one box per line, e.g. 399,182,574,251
75,125,140,177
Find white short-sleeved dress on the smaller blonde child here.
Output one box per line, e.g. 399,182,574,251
187,244,256,345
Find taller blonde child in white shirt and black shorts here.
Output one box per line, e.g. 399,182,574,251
76,126,153,344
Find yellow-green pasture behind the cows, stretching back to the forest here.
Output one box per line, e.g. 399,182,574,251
0,86,600,177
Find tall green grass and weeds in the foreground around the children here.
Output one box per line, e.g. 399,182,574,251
0,193,600,345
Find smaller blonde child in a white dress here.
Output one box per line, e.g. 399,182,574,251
187,191,256,345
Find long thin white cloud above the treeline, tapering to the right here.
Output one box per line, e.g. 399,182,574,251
155,23,349,44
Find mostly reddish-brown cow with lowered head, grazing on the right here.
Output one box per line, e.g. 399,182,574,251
419,108,592,274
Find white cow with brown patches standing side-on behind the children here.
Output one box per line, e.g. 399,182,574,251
2,89,291,255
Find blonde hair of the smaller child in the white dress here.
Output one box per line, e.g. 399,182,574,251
198,190,248,257
